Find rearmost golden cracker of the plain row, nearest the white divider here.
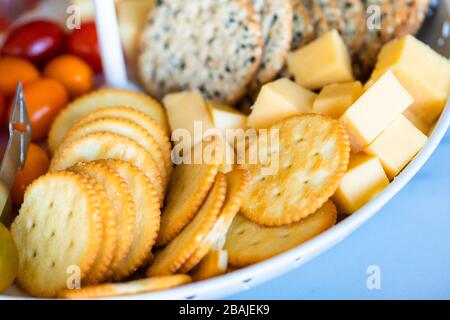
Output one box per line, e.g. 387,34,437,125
48,89,169,153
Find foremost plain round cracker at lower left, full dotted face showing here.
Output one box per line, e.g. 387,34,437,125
11,172,103,297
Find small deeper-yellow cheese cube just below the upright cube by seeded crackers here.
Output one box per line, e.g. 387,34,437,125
313,81,363,118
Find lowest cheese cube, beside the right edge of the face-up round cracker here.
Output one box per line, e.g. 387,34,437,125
333,154,389,214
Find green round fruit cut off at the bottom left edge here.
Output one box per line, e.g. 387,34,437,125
0,223,19,293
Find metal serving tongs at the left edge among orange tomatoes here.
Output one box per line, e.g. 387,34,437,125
0,82,31,225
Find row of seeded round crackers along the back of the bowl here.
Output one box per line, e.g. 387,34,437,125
137,0,429,104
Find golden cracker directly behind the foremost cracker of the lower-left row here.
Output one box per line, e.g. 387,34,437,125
83,175,120,284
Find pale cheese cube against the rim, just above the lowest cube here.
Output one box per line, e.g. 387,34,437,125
365,115,427,180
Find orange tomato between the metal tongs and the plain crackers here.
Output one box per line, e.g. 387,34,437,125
11,143,50,206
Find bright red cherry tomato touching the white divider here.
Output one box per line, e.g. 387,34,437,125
66,22,102,73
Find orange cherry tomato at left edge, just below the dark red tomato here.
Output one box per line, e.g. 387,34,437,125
0,57,39,97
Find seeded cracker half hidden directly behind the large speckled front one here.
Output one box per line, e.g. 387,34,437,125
250,0,293,91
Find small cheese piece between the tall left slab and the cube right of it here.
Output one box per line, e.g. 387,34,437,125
207,101,247,129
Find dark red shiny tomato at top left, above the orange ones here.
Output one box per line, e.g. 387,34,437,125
1,20,65,65
